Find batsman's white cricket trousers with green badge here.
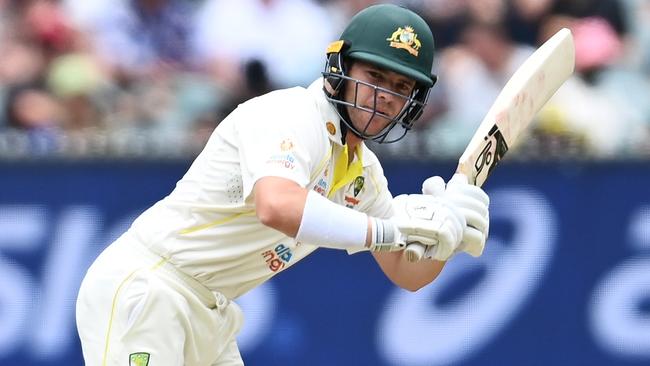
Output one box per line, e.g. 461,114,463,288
76,233,243,366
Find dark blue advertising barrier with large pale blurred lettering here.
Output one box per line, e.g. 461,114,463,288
0,162,650,366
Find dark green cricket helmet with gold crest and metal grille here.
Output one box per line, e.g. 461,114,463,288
323,4,437,143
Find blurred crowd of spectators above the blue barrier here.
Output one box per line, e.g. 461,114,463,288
0,0,650,159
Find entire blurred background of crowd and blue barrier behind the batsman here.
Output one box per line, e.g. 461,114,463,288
0,0,650,366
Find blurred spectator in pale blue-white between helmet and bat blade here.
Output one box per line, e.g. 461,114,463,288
420,21,533,157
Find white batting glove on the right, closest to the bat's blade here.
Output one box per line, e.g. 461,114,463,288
422,174,490,258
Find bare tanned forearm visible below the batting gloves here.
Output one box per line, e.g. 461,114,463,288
373,251,446,291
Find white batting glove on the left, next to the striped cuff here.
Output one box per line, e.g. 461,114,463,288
391,194,467,260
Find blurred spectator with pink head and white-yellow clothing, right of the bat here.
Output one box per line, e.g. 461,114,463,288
539,16,650,159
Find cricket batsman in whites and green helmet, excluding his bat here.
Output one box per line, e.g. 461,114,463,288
76,5,489,366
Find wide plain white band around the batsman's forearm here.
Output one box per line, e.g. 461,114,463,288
296,191,368,249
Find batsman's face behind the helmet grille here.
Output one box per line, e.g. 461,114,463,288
344,61,415,135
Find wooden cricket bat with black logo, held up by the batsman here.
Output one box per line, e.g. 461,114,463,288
405,28,575,262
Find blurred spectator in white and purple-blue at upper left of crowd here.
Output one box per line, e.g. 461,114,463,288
67,0,199,79
